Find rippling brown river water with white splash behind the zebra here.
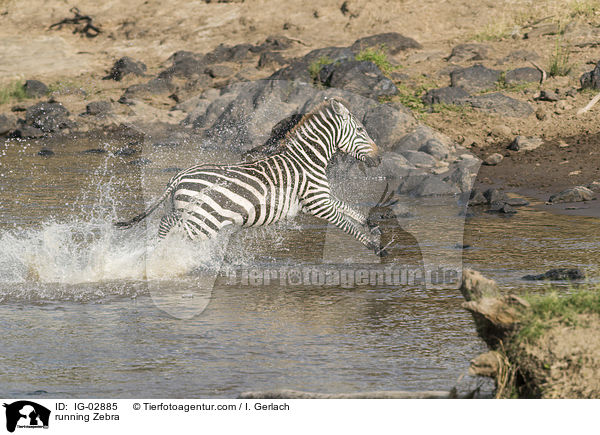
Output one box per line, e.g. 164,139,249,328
0,138,600,398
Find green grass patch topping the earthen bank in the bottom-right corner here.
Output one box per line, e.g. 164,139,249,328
517,286,600,342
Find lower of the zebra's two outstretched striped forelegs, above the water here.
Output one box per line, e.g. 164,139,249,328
305,198,387,256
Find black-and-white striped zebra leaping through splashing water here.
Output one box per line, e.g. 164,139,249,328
115,99,385,255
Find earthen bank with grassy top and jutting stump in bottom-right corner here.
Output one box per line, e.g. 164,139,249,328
461,270,600,398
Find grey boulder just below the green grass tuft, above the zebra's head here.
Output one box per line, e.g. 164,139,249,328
322,60,398,98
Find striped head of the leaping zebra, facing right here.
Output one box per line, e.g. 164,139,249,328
331,100,381,166
